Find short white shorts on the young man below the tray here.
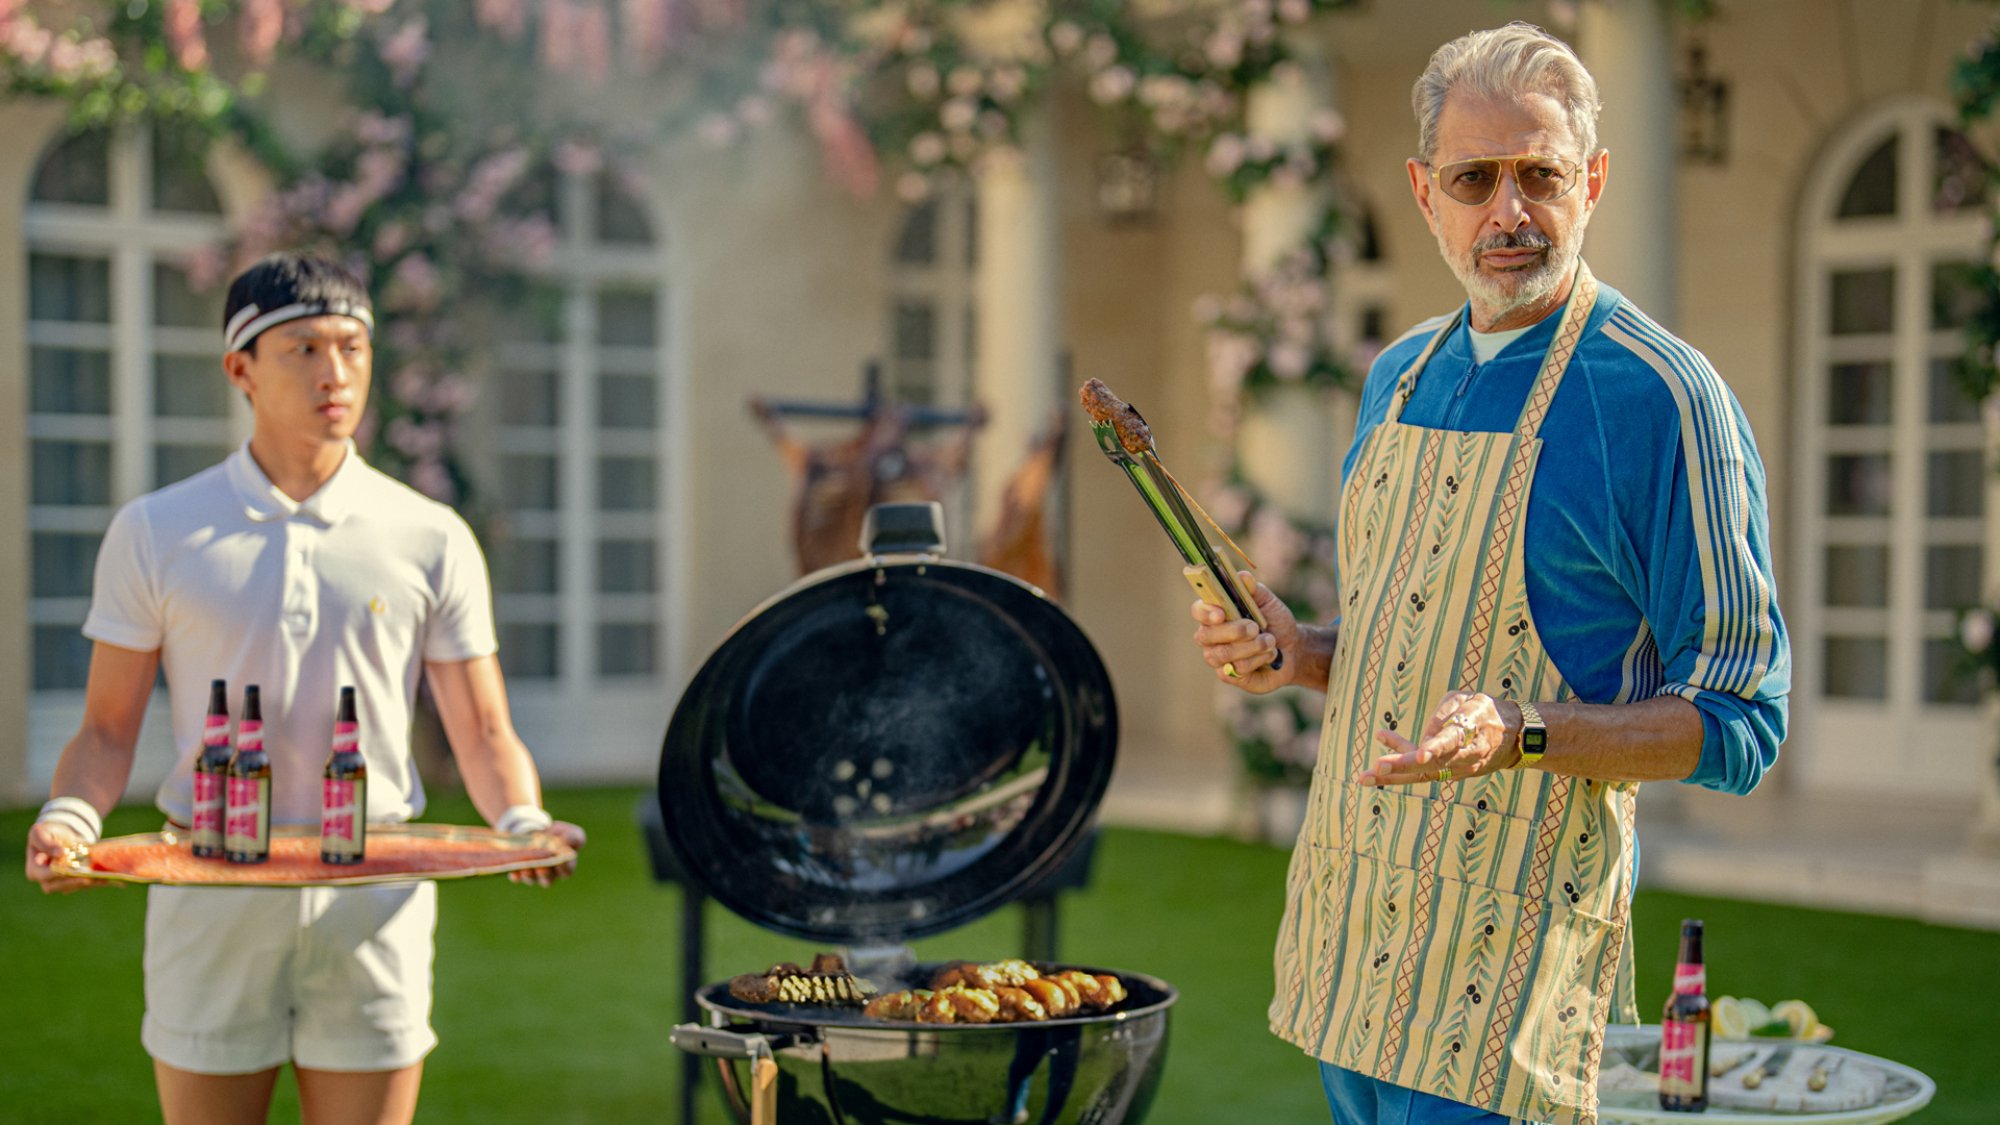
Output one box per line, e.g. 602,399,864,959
140,883,438,1075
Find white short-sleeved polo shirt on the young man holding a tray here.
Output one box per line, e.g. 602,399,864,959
84,442,498,825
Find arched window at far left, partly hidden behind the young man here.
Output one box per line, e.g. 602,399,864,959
22,130,234,696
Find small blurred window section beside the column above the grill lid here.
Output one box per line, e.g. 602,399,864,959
886,186,978,406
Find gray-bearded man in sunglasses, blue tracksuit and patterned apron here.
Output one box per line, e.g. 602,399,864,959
1192,24,1790,1125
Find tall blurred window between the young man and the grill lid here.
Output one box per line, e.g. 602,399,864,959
478,168,678,744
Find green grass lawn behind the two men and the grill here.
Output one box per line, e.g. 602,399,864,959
0,789,2000,1125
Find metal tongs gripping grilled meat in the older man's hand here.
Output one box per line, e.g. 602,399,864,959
1076,378,1284,675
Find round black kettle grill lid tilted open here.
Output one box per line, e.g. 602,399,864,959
660,528,1118,945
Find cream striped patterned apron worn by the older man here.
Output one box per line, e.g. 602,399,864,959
1270,264,1638,1125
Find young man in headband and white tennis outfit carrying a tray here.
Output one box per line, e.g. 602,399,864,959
28,254,584,1125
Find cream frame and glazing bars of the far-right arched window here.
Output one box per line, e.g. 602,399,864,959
1786,98,1994,797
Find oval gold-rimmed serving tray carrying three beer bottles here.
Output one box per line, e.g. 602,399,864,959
54,825,576,887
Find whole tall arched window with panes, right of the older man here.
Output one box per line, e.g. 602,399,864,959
1786,100,1990,789
